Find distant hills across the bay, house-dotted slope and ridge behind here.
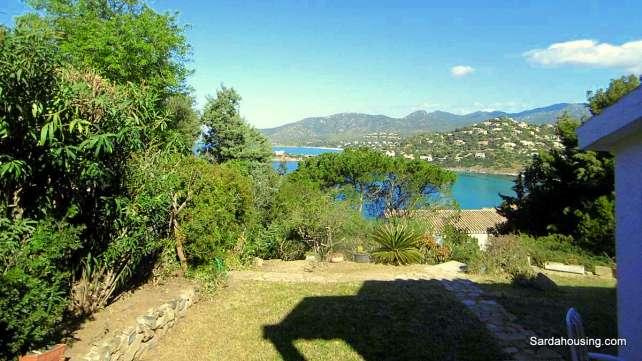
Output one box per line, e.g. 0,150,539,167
262,103,589,174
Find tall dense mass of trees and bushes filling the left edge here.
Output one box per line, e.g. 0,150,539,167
0,1,198,358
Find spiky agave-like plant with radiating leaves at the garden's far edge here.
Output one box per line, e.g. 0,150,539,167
372,223,423,266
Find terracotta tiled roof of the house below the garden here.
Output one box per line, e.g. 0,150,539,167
414,208,506,233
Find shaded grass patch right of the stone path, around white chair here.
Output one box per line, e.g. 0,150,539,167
480,276,617,355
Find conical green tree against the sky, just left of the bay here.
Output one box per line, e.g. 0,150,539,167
201,86,272,163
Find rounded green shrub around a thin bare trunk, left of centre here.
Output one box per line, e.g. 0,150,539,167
128,153,257,266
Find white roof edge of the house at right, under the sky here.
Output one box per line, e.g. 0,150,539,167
577,87,642,150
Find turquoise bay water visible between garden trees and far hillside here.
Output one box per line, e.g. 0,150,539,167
272,147,515,209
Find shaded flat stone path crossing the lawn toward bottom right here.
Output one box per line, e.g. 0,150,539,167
441,279,564,361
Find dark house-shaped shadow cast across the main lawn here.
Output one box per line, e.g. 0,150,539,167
263,280,503,361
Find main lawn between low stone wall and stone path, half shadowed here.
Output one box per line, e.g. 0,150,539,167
144,280,502,361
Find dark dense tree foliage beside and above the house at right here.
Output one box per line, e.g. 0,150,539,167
499,77,639,256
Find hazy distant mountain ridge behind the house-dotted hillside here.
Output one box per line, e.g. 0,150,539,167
261,103,590,146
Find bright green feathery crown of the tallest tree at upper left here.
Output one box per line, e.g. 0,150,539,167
24,0,190,94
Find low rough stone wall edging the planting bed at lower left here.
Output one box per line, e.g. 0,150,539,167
82,289,197,361
